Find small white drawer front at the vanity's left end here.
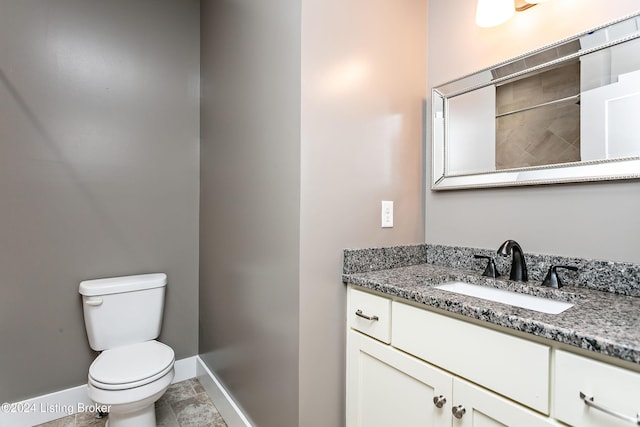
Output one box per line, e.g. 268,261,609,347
347,288,391,344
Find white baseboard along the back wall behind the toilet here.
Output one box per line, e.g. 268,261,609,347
0,356,201,427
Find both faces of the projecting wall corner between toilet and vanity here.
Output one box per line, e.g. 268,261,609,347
200,0,426,427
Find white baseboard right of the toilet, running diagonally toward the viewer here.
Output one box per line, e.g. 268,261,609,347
196,356,253,427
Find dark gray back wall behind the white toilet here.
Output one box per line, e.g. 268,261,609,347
0,0,199,401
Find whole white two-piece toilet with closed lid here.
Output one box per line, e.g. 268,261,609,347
79,273,175,427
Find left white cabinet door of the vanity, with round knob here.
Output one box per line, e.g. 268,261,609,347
347,331,452,427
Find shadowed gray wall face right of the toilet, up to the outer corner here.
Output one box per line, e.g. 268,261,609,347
200,0,300,426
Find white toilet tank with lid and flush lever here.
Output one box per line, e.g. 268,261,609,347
79,273,167,351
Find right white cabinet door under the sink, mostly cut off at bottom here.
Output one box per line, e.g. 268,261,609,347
452,378,560,427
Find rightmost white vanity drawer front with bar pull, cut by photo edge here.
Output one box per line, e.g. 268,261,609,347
554,350,640,427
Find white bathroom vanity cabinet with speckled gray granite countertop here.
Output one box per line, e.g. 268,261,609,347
343,245,640,427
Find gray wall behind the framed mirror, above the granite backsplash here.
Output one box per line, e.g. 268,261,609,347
425,0,640,262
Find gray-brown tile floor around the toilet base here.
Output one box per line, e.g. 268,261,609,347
35,378,227,427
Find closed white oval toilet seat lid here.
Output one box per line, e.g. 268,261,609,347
89,340,175,390
